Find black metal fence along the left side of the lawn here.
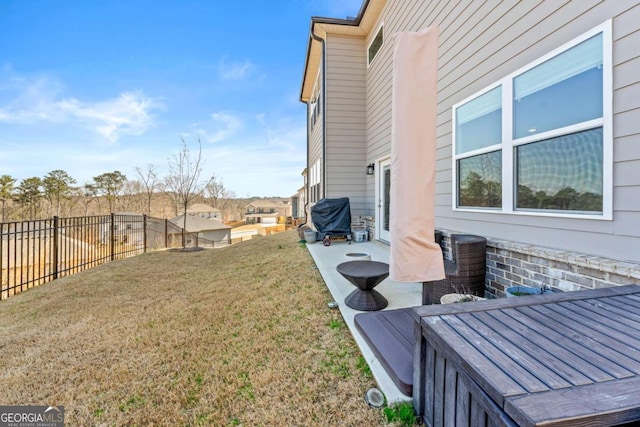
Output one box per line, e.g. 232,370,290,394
0,214,222,300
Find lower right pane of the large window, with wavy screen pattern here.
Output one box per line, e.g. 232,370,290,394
515,128,603,212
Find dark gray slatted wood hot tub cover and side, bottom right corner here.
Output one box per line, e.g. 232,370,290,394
413,285,640,426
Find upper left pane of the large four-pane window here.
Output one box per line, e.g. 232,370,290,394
455,86,502,154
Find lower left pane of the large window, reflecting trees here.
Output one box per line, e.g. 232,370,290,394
458,151,502,208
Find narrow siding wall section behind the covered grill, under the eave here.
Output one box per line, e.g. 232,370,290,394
325,35,367,215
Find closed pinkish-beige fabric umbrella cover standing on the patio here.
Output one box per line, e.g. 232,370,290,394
389,26,445,282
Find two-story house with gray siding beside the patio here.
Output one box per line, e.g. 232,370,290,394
300,0,640,294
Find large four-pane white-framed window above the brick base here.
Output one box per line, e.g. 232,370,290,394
453,22,612,219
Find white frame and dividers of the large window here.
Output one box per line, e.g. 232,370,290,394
451,19,613,221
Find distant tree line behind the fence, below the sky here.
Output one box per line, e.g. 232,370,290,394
0,140,246,222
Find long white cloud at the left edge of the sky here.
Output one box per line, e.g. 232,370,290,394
0,71,165,142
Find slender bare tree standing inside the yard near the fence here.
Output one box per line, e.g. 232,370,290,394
166,137,204,248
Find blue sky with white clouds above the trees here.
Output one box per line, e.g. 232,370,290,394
0,0,362,197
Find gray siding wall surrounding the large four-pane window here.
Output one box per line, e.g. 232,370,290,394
366,0,640,262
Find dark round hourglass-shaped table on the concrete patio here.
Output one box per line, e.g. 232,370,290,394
336,261,389,311
